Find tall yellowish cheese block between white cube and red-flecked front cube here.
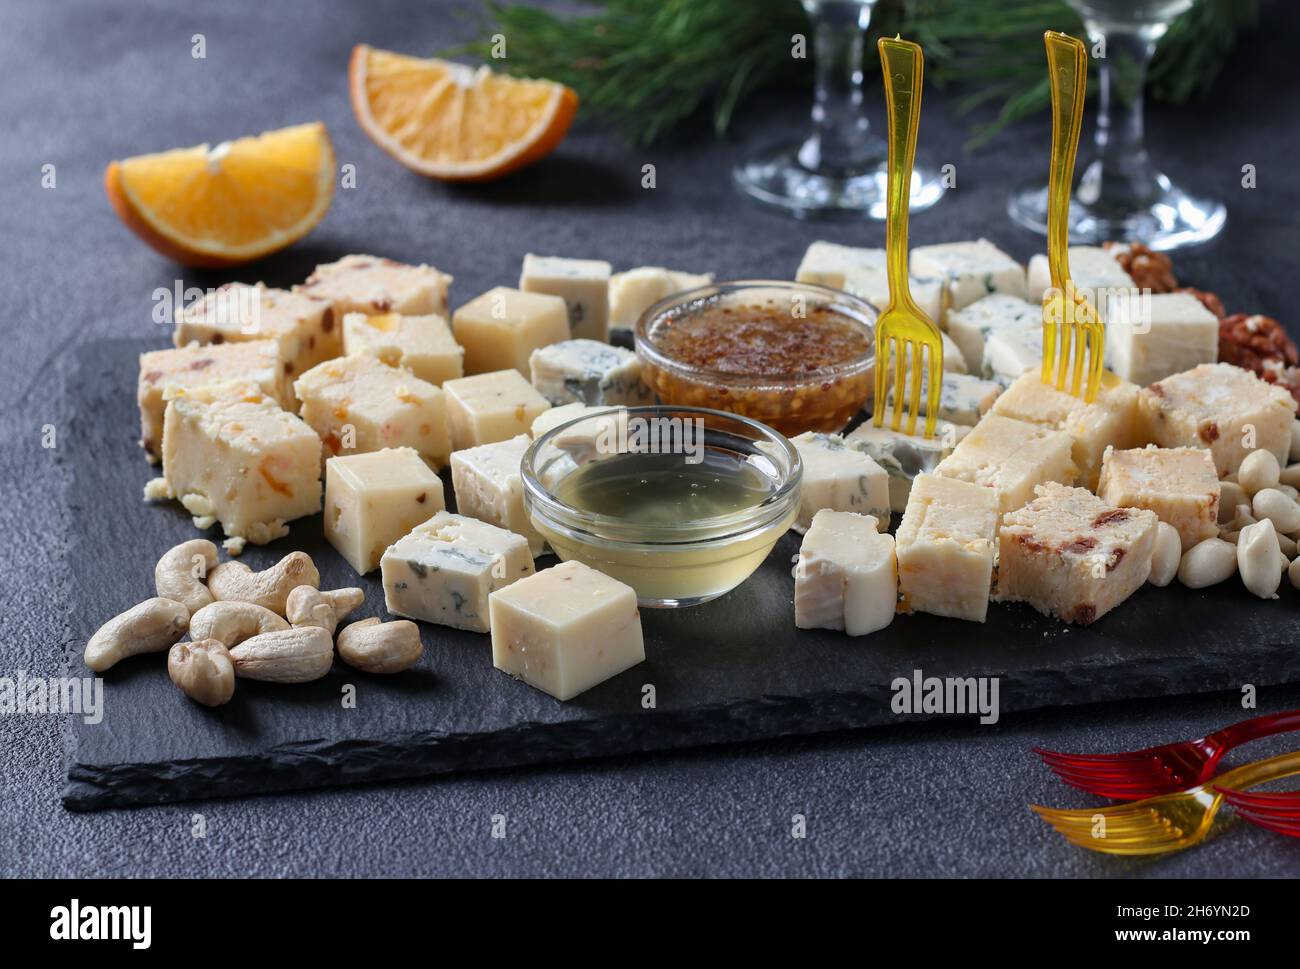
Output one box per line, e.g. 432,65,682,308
896,475,997,623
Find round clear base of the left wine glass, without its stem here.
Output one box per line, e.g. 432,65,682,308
732,146,946,219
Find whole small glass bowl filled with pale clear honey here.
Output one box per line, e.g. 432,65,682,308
520,406,803,607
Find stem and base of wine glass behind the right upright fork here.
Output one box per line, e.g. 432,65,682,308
1008,0,1227,250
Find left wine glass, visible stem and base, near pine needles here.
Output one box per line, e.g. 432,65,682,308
732,0,945,219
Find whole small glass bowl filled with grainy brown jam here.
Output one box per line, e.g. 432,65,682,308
634,280,876,436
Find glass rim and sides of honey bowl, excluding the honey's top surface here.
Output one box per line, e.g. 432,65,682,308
521,406,803,607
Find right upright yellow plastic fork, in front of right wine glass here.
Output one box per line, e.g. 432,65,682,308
1043,30,1105,403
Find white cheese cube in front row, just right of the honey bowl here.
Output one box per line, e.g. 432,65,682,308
794,510,898,636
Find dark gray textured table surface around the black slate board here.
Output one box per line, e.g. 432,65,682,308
0,0,1300,877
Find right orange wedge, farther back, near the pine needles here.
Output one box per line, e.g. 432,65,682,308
348,44,577,182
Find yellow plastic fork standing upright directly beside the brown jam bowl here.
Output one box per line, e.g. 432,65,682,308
872,38,944,437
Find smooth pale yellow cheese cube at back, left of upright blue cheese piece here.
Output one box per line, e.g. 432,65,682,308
451,286,569,376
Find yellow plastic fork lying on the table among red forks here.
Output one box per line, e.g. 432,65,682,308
1030,750,1300,855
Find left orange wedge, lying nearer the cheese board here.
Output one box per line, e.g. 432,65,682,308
104,121,334,268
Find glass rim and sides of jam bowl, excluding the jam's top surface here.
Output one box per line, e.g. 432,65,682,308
633,280,876,437
